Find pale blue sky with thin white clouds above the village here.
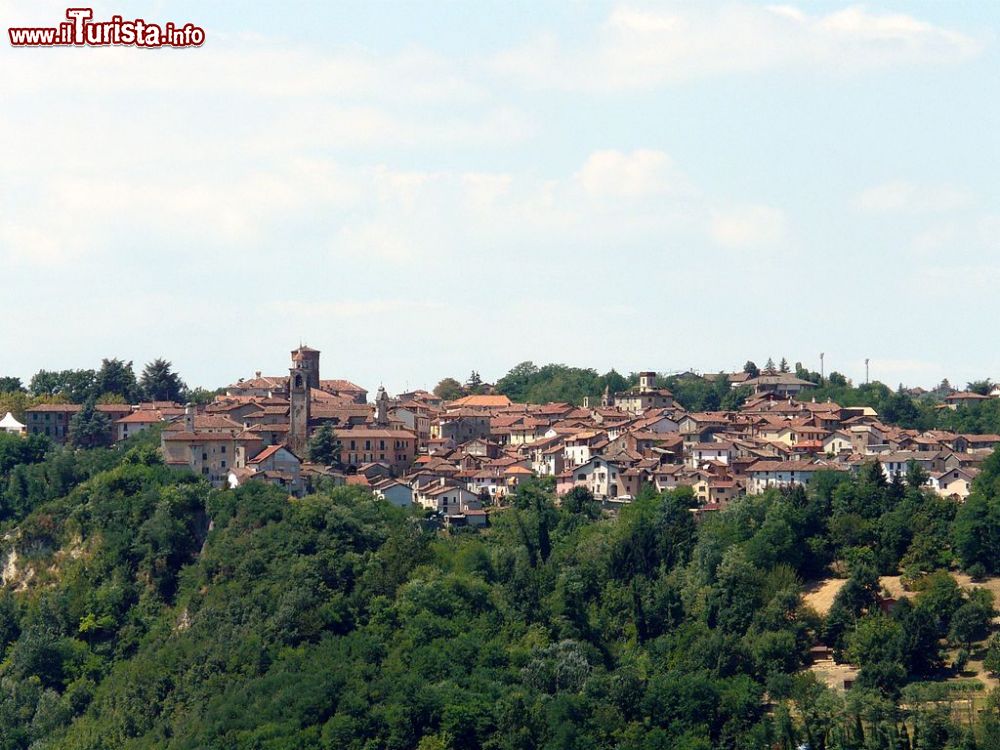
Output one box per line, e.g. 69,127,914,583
0,0,1000,392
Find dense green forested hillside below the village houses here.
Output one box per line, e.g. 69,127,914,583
0,434,1000,750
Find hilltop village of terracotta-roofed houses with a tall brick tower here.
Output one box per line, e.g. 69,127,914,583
15,346,1000,525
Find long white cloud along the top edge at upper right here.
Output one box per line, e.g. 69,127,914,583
493,4,982,90
